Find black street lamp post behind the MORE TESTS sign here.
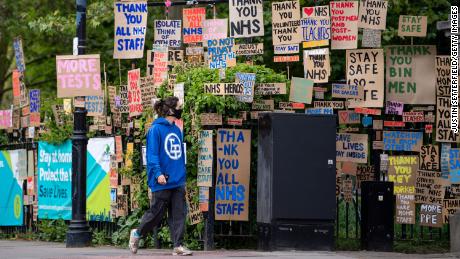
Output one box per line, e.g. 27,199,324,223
66,0,91,247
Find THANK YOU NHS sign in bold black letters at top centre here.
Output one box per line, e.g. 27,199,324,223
228,0,264,38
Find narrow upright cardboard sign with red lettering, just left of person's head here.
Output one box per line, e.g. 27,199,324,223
128,68,143,117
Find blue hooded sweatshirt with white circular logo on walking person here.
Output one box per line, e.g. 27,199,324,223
147,117,185,192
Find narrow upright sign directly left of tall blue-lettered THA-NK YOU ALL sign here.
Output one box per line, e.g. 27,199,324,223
196,130,214,187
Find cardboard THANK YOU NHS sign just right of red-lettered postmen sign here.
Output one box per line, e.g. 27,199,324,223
358,0,388,30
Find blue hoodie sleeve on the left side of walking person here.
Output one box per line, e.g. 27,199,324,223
147,126,162,179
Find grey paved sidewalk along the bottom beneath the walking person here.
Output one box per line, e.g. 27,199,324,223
0,240,459,259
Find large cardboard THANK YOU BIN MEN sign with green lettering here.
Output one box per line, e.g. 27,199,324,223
386,45,436,104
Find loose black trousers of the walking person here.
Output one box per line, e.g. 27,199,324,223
137,186,187,247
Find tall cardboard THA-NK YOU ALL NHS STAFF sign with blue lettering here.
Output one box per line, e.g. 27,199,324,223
215,129,251,221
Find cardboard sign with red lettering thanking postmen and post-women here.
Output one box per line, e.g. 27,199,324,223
330,1,359,49
